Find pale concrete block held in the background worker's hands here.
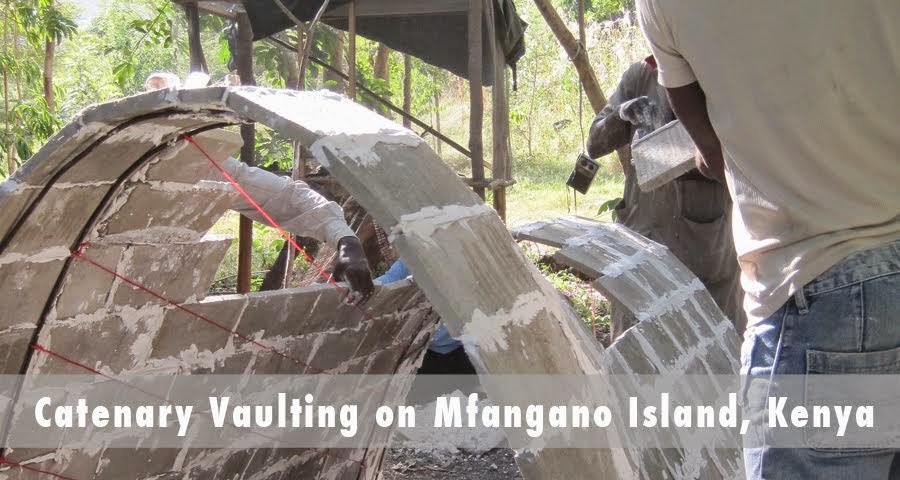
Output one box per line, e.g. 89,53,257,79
631,120,697,192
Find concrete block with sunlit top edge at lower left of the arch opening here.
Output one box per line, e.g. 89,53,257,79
151,295,247,358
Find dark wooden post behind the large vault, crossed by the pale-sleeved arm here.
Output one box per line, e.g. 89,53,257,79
235,13,256,293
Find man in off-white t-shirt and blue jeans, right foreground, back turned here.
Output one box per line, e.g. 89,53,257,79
637,0,900,479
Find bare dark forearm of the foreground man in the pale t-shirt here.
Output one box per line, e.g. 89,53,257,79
666,82,725,183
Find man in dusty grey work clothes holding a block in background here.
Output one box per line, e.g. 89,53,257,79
587,56,746,339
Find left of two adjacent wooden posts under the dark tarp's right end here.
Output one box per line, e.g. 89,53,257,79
468,0,485,200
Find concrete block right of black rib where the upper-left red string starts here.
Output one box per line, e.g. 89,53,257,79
56,244,125,318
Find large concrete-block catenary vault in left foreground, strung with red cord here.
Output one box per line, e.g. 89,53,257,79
0,87,733,478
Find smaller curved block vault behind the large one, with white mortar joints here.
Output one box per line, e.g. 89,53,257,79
513,217,744,479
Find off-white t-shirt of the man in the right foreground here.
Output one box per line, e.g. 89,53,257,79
637,0,900,323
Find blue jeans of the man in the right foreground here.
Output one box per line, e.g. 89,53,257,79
741,242,900,480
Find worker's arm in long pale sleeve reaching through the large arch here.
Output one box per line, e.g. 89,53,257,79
222,158,375,303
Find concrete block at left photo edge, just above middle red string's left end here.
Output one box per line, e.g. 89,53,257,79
0,259,65,331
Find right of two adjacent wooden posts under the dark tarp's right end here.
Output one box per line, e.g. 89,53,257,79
488,0,512,222
